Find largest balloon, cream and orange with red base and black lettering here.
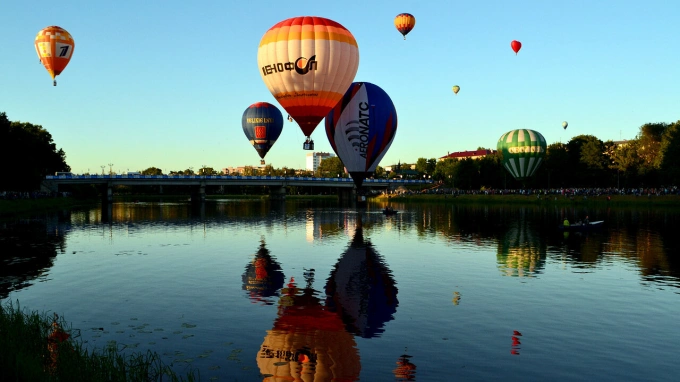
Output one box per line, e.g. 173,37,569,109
257,16,359,150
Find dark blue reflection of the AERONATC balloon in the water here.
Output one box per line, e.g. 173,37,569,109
326,218,399,338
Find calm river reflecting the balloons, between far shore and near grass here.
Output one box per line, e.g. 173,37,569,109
0,199,680,382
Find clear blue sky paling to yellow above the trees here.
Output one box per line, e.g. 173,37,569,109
0,0,680,173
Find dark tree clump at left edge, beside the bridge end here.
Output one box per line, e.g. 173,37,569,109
0,113,71,191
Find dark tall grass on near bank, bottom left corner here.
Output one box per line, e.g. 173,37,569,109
0,302,197,382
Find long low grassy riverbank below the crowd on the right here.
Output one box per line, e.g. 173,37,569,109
375,194,680,208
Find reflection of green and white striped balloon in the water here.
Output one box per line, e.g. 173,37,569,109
497,220,546,277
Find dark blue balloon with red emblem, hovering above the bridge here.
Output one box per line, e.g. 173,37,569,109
241,102,283,164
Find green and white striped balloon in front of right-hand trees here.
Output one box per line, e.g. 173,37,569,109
498,129,547,180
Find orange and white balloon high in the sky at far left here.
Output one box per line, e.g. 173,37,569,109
35,26,76,86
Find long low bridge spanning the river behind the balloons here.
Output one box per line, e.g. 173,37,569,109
41,174,432,203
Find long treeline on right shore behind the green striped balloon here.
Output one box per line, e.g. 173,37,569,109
412,121,680,189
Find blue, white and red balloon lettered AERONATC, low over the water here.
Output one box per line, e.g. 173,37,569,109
326,82,397,188
